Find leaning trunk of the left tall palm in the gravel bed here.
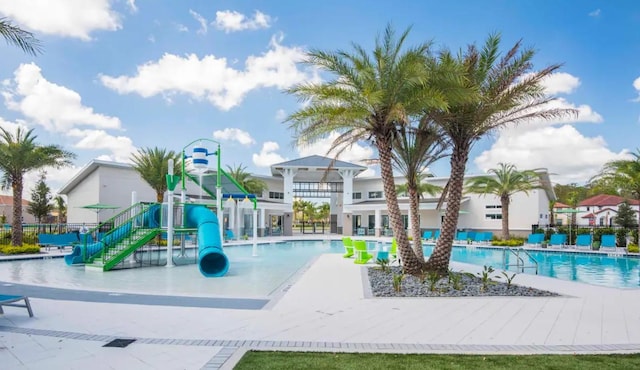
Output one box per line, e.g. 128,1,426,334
376,137,423,275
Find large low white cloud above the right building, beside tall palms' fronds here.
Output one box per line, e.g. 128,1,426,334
474,125,626,184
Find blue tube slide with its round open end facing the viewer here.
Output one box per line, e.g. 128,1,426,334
187,205,229,277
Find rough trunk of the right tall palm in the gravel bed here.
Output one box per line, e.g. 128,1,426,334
426,148,469,275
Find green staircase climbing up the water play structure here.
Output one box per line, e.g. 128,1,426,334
87,228,160,271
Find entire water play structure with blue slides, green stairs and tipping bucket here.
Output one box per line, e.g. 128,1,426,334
65,139,257,277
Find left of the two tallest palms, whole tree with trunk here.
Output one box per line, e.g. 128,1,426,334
287,26,446,274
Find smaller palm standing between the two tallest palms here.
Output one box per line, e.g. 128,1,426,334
392,125,446,262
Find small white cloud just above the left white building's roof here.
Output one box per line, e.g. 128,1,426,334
67,129,137,162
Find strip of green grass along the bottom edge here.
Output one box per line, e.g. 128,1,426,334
234,351,640,370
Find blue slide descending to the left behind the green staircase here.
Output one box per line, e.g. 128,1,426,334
64,205,160,266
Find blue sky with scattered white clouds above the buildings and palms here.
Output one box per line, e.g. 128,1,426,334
0,0,640,197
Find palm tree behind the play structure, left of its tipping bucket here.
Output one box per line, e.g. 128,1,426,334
131,147,182,203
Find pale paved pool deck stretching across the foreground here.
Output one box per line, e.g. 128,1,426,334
0,238,640,370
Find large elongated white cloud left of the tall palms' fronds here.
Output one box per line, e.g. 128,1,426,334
100,37,317,110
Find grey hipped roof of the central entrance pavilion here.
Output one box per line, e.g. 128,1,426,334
271,155,367,182
